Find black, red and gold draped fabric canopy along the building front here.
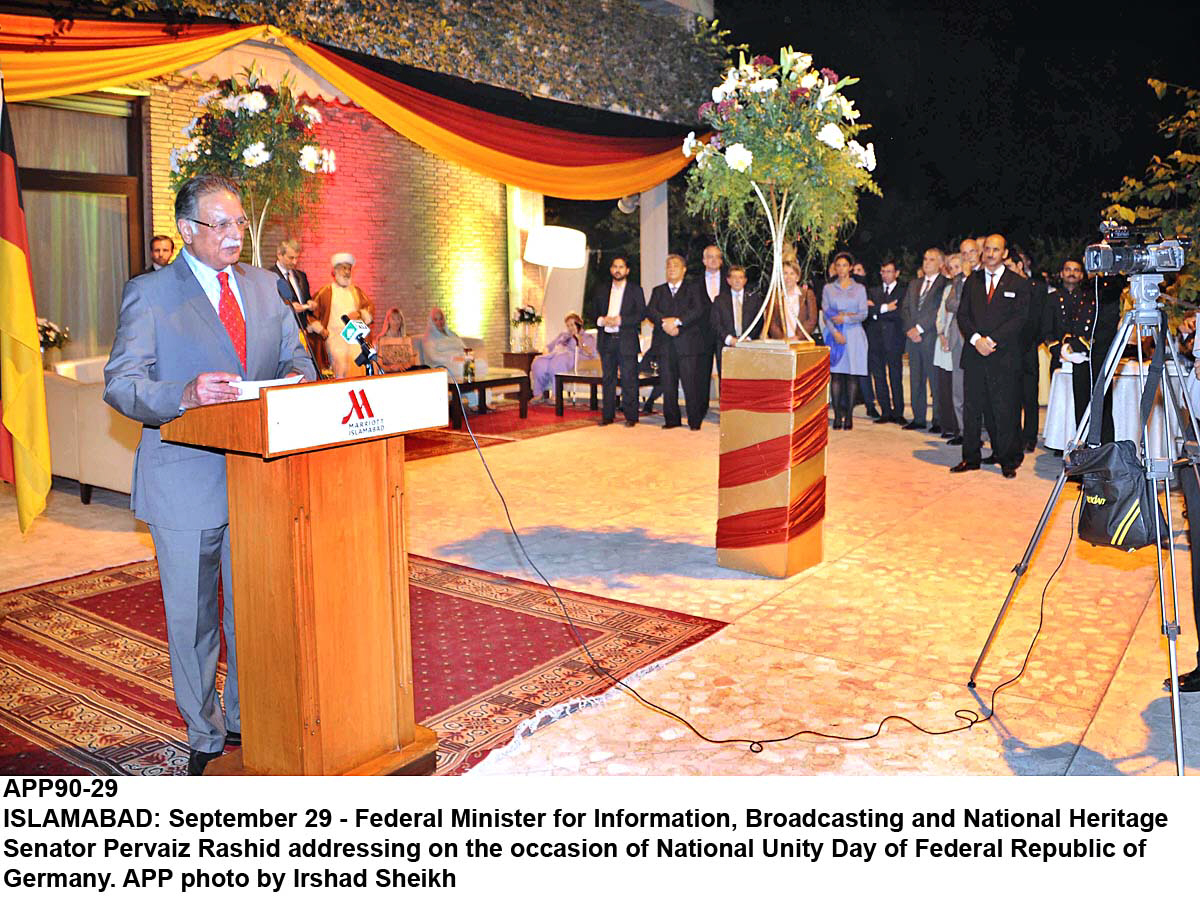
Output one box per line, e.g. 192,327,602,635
0,14,689,199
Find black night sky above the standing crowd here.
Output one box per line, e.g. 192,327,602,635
715,0,1200,271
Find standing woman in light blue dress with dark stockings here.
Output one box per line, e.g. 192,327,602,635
821,252,866,429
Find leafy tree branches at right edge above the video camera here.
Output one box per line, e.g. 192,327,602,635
1104,78,1200,307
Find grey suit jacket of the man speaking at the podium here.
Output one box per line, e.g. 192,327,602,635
104,253,316,530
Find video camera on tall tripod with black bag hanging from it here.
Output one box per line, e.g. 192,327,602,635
967,222,1200,776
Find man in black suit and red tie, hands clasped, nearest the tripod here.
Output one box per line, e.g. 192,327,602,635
950,234,1030,478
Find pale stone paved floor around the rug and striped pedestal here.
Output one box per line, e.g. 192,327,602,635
0,405,1200,775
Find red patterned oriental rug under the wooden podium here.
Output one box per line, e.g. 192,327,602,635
0,555,725,776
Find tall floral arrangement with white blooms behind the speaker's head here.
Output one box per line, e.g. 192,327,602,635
170,67,336,265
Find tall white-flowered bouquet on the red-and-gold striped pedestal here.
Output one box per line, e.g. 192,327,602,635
683,47,880,332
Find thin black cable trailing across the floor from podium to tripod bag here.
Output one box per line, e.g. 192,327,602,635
432,365,1084,753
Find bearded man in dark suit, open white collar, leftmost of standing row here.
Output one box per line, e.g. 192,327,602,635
592,255,646,427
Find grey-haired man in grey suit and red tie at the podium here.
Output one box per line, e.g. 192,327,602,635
104,175,316,775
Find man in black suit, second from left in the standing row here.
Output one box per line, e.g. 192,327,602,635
646,254,713,429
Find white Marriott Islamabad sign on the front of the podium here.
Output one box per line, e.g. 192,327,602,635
263,371,450,458
